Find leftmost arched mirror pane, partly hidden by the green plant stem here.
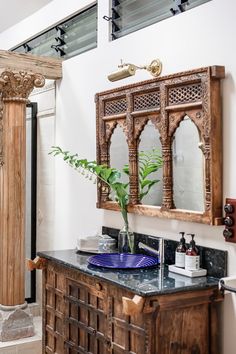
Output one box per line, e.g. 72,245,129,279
110,125,129,200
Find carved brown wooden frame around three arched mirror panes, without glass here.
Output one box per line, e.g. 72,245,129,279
95,66,224,225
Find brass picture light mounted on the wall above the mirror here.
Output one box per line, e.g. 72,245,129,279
107,59,162,81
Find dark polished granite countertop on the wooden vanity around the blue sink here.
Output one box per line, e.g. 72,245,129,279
38,250,219,296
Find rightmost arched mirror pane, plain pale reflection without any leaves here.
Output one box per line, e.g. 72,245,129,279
172,116,204,211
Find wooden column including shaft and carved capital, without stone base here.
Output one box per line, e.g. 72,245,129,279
0,70,45,306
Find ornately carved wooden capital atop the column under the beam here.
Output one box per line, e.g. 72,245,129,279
0,70,45,102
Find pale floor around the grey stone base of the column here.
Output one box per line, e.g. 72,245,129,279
0,316,42,354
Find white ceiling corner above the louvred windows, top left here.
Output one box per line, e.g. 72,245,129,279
0,0,52,32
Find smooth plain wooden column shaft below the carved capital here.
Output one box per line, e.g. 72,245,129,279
0,102,26,306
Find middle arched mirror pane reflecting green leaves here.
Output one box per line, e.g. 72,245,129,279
139,121,163,206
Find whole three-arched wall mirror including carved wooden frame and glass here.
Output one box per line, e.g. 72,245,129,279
96,66,225,225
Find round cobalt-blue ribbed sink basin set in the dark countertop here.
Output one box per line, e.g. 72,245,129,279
88,253,159,269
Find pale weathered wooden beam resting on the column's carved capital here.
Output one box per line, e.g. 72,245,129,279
0,50,62,80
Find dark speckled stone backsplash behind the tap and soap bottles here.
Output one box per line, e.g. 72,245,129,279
102,226,227,278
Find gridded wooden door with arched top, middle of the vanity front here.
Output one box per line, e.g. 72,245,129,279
65,278,110,354
